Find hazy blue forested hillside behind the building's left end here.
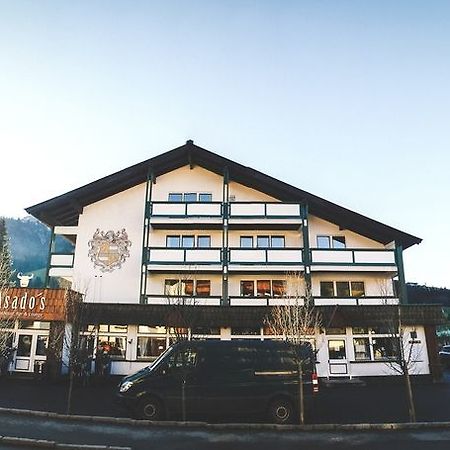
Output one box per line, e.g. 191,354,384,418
5,216,72,287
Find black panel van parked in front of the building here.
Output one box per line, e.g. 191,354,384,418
117,340,318,423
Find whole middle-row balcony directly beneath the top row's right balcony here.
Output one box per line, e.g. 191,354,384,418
228,248,303,272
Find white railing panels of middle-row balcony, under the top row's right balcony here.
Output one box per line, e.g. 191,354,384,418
229,248,303,265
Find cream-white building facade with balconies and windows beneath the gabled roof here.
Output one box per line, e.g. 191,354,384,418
44,156,429,377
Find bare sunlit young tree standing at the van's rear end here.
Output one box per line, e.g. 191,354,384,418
268,273,322,424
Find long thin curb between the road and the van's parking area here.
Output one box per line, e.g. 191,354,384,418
0,407,450,432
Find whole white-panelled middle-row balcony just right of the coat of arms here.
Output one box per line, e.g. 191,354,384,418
147,247,222,272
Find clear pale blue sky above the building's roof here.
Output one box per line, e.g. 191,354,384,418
0,0,450,288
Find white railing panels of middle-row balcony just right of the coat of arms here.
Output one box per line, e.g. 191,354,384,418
147,247,222,265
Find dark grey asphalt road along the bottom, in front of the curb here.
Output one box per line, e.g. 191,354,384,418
0,413,450,450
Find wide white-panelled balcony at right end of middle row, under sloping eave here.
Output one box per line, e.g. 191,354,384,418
311,248,397,272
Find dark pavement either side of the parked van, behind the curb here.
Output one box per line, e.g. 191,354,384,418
0,377,450,424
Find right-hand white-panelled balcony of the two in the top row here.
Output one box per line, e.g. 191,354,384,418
228,202,302,229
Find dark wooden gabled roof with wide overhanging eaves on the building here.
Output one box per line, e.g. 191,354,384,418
26,141,421,248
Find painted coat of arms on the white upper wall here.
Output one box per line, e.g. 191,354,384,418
88,228,131,272
